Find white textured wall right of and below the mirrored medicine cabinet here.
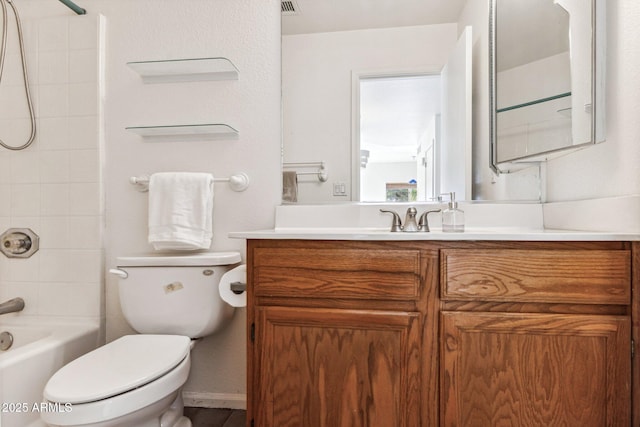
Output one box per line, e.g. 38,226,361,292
547,0,640,202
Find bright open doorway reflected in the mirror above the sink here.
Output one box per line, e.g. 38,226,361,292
356,75,440,202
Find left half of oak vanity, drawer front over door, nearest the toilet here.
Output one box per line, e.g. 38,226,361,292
247,240,438,427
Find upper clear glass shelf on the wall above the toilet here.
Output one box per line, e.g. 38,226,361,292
127,58,238,83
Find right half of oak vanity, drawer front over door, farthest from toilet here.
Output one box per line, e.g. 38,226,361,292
440,243,631,427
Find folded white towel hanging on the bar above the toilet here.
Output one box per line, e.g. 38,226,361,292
149,172,213,250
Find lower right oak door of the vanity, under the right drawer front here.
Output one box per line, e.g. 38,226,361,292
440,312,631,427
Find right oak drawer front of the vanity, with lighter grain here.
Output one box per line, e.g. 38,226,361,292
440,249,631,305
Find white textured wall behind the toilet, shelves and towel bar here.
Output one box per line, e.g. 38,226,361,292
97,0,281,406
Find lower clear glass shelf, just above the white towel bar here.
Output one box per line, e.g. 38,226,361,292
126,124,238,142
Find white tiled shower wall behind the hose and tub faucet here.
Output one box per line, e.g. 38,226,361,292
0,15,104,320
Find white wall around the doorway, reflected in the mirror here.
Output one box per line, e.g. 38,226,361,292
282,24,457,203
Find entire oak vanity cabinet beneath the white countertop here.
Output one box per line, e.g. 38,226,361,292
247,240,638,427
